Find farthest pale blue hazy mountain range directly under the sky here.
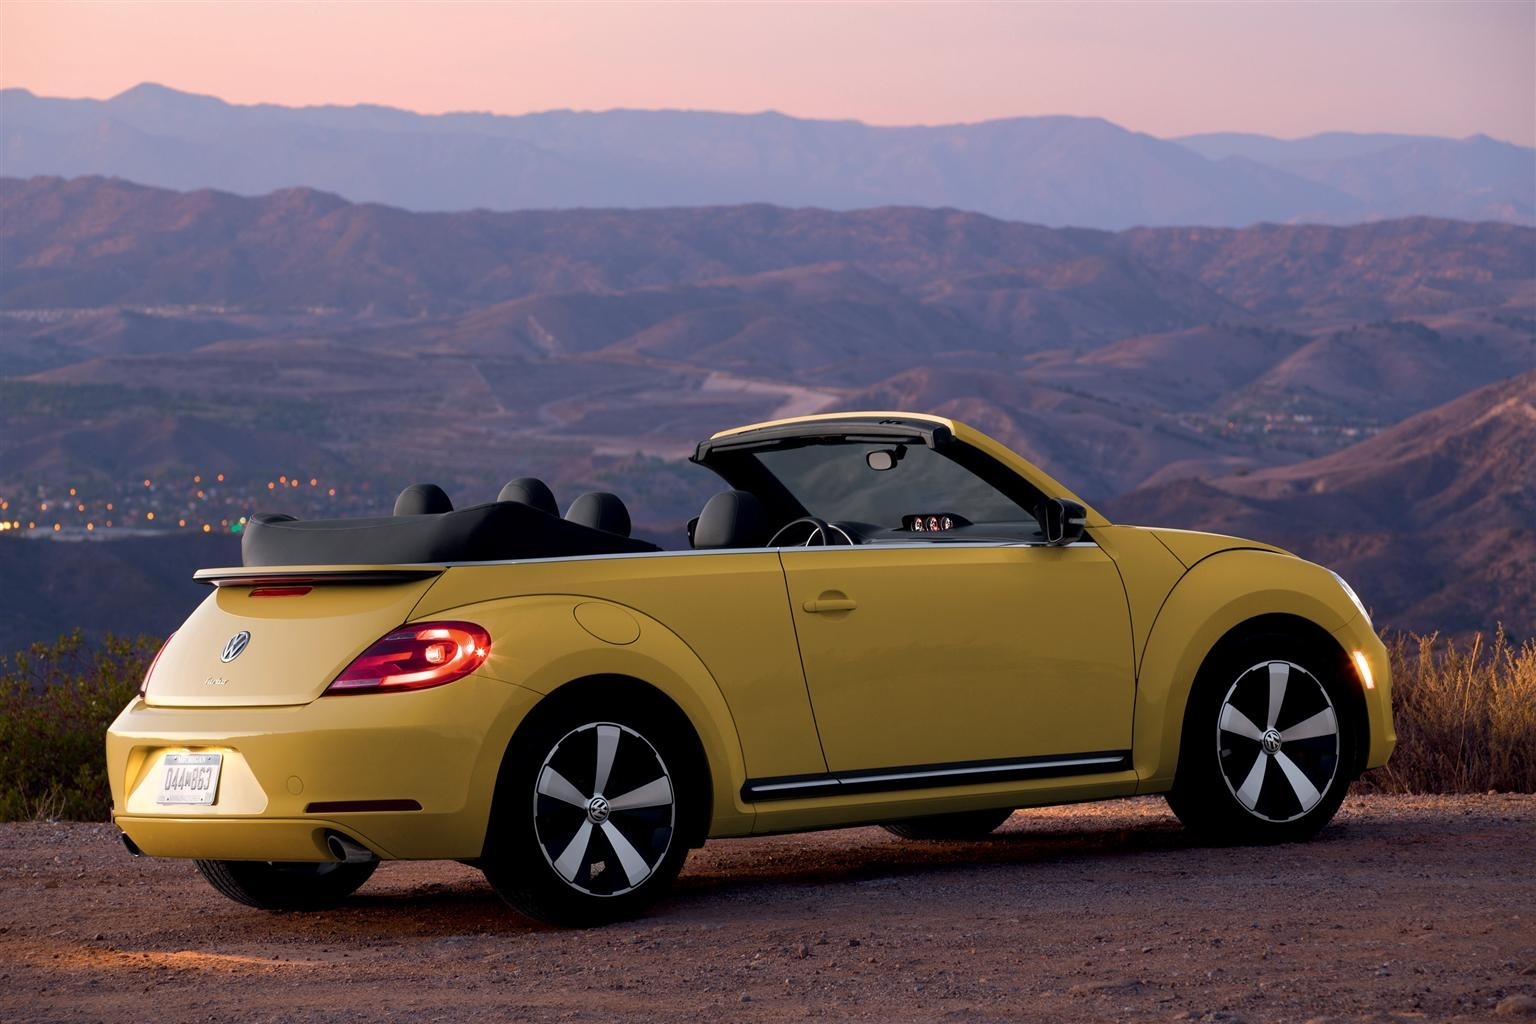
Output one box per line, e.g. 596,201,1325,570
0,84,1536,230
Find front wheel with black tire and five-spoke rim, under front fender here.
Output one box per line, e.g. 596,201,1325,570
1167,636,1356,843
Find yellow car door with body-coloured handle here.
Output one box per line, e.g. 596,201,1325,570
780,542,1135,773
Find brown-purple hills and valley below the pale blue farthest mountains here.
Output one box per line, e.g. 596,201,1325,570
0,171,1536,648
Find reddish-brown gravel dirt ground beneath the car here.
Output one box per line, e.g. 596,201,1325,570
0,795,1536,1024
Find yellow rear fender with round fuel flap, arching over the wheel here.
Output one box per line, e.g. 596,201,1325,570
420,596,754,837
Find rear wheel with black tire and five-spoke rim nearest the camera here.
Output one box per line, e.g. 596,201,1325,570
481,695,708,927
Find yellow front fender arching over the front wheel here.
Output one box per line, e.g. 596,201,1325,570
1132,550,1359,792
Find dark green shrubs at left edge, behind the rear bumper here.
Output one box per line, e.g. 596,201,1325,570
0,629,160,821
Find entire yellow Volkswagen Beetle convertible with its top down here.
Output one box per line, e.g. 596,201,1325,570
106,413,1396,924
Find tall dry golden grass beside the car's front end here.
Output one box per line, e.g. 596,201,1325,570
1362,629,1536,792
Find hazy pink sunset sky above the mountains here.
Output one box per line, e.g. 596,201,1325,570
9,0,1536,146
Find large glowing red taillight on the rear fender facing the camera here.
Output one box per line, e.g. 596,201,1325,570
326,622,490,694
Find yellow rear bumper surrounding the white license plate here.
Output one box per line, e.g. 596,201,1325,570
106,676,539,861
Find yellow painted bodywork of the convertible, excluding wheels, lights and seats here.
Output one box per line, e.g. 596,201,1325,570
108,413,1395,890
